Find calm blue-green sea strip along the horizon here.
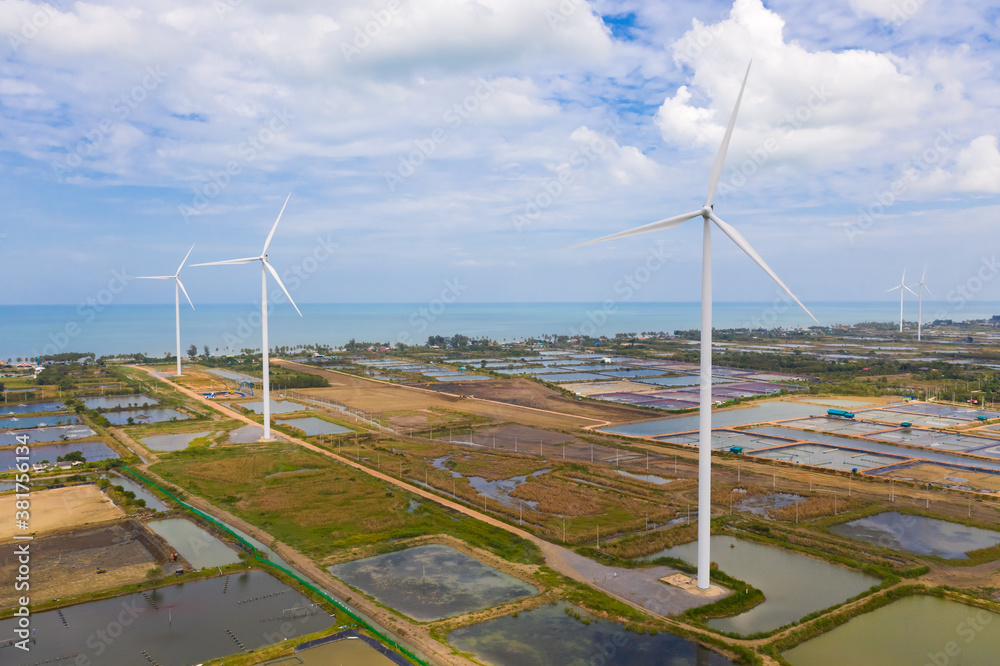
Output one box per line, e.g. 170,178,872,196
0,299,1000,359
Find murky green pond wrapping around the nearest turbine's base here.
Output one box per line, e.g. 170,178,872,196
643,535,879,636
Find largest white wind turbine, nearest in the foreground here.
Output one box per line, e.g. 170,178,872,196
567,65,819,590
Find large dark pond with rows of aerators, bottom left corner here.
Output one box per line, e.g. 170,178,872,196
0,571,333,666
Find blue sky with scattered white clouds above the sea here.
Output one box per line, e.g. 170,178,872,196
0,0,1000,312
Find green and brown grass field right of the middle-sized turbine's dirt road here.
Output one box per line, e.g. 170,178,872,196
150,444,542,563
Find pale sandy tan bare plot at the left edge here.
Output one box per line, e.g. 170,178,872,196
0,484,124,541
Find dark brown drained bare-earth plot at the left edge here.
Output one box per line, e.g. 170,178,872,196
0,520,176,608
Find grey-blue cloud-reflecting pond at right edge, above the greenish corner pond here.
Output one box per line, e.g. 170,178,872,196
830,511,1000,560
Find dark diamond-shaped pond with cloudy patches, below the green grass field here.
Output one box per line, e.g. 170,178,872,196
329,544,538,622
